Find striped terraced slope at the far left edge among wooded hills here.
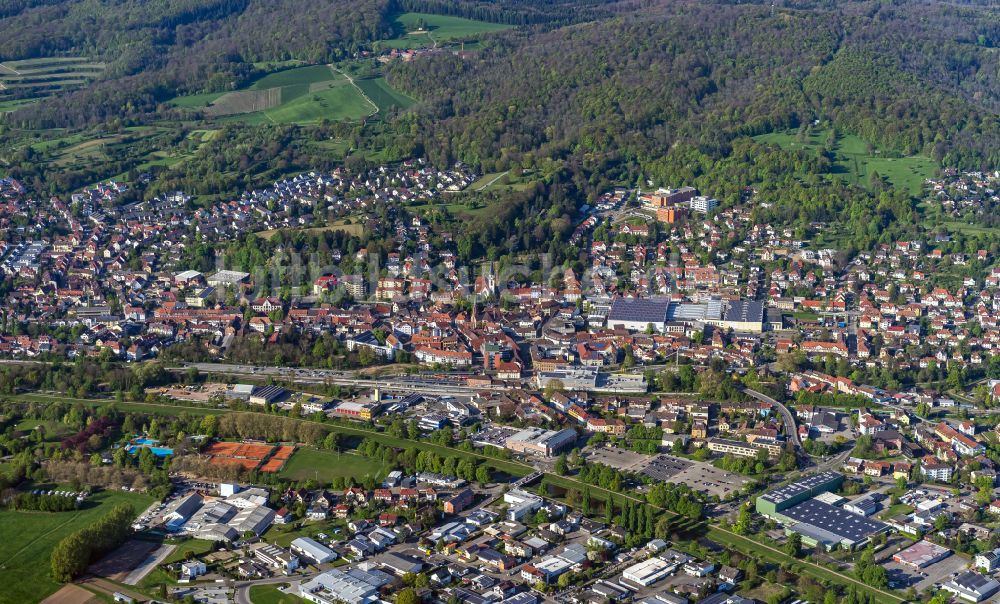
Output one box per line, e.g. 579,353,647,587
0,57,105,103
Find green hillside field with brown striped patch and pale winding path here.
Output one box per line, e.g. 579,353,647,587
171,65,384,124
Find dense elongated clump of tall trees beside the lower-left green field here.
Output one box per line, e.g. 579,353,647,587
51,504,135,583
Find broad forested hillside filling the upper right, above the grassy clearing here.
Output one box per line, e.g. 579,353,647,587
390,1,1000,173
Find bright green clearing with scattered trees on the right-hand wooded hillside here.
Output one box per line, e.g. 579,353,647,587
754,129,937,195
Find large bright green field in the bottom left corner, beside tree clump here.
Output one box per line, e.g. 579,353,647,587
0,491,153,604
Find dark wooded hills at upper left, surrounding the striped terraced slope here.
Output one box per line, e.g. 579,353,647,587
0,0,392,128
